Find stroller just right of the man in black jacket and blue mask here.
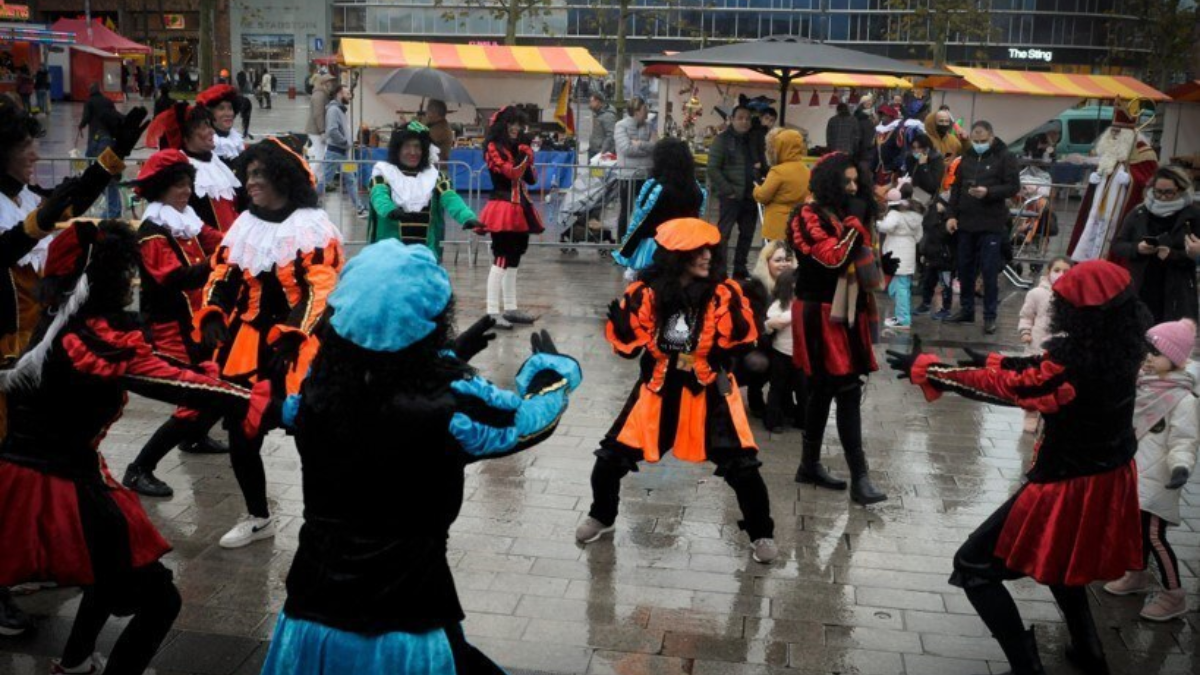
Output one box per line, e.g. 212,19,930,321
1004,166,1058,289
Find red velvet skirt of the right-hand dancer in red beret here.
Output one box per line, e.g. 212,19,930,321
995,461,1142,586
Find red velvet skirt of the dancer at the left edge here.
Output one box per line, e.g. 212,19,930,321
0,455,170,586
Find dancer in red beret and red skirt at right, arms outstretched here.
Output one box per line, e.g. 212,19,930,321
888,261,1150,675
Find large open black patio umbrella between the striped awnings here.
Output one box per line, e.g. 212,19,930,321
642,36,954,126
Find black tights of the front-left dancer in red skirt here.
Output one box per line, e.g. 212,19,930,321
62,562,181,675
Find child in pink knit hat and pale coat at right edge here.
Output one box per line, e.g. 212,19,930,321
1104,319,1198,621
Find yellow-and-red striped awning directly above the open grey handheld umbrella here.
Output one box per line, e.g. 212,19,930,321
338,37,608,76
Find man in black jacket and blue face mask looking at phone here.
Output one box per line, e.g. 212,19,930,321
946,120,1021,335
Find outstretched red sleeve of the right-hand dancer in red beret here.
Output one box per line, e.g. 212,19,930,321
911,354,1075,413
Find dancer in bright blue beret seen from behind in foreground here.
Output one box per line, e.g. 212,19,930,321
263,240,582,675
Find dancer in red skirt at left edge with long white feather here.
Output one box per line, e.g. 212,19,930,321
0,220,271,675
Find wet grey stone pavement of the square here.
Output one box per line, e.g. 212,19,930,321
0,97,1200,675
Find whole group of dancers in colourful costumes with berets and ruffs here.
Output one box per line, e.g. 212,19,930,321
0,85,1186,675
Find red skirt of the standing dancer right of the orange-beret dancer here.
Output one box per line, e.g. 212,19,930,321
792,300,880,377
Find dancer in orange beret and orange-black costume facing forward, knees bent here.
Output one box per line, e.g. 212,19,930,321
575,219,779,563
